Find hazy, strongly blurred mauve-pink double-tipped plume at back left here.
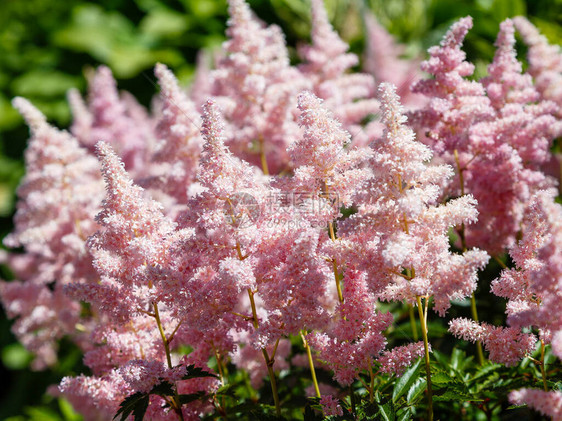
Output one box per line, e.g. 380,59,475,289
70,66,156,179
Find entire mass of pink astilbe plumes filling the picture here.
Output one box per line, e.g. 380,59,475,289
0,0,562,420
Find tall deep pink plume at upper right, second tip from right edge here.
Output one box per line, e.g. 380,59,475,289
460,19,556,255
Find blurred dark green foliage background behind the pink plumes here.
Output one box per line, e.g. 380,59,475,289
0,0,562,421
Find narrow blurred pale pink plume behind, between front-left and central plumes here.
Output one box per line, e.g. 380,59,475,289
149,64,203,204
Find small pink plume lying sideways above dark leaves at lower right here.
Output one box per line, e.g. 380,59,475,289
449,318,537,366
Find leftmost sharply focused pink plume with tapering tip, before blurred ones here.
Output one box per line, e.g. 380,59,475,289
80,142,175,320
